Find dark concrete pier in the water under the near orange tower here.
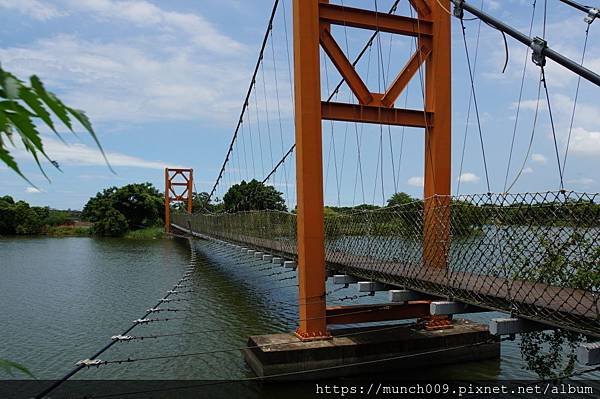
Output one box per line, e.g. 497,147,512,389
244,319,500,380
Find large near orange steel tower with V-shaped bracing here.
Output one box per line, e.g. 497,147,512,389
293,0,451,340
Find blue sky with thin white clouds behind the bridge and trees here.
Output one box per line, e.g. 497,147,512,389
0,0,600,209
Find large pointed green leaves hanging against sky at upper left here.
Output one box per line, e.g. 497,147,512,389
0,67,114,184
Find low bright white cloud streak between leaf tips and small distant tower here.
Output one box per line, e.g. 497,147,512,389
14,137,182,170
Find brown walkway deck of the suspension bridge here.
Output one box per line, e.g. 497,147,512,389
173,224,600,336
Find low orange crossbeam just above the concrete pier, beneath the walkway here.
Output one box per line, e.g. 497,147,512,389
327,301,430,324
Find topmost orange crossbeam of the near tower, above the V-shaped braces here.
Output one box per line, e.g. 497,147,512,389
319,3,432,36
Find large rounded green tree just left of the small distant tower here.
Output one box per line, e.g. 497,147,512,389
82,183,164,236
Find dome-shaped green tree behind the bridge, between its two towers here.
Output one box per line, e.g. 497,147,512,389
223,179,287,212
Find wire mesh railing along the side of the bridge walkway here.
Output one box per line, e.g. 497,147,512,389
174,192,600,336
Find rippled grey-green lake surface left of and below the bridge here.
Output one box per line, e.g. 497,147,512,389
0,237,600,396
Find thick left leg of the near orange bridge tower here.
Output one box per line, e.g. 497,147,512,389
293,0,328,339
